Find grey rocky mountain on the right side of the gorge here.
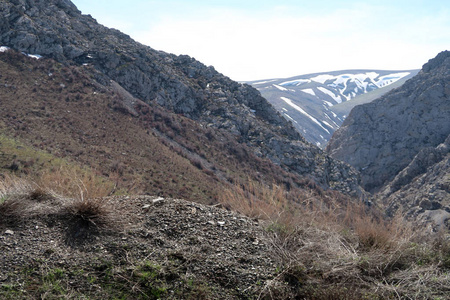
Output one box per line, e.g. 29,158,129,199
326,51,450,230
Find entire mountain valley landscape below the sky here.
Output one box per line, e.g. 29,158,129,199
0,0,450,299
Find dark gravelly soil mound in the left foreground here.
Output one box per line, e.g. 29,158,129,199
0,196,277,299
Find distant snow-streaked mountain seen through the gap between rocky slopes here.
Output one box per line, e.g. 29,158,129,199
248,70,418,147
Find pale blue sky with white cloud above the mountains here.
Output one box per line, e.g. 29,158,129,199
72,0,450,81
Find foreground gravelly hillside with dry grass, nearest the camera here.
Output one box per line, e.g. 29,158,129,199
0,179,450,300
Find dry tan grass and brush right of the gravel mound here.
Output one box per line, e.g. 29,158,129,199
221,179,450,299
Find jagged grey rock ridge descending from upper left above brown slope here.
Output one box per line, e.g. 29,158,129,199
0,0,361,194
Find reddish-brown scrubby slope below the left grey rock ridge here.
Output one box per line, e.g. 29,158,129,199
0,52,310,203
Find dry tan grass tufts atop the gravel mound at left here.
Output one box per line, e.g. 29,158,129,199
0,168,124,229
